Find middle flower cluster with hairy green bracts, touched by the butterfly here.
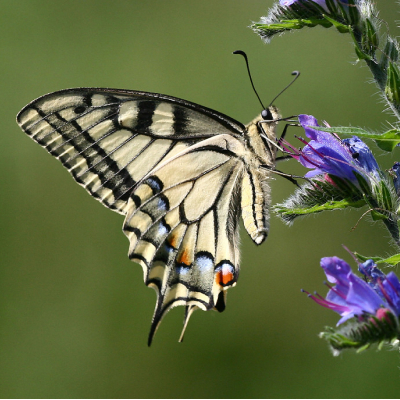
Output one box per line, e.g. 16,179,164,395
274,114,400,245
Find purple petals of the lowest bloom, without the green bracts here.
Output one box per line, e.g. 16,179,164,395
306,257,400,325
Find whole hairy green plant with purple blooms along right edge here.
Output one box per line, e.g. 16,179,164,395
252,0,400,352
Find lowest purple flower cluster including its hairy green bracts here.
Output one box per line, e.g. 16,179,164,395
304,257,400,354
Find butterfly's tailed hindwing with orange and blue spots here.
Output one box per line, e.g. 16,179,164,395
124,135,244,341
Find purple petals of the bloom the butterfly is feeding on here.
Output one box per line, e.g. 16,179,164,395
283,114,381,183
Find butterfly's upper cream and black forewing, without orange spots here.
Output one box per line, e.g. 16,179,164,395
17,88,244,214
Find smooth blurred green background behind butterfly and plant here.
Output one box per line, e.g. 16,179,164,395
0,0,400,398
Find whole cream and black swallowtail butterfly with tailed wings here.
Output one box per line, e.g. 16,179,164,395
17,50,298,345
